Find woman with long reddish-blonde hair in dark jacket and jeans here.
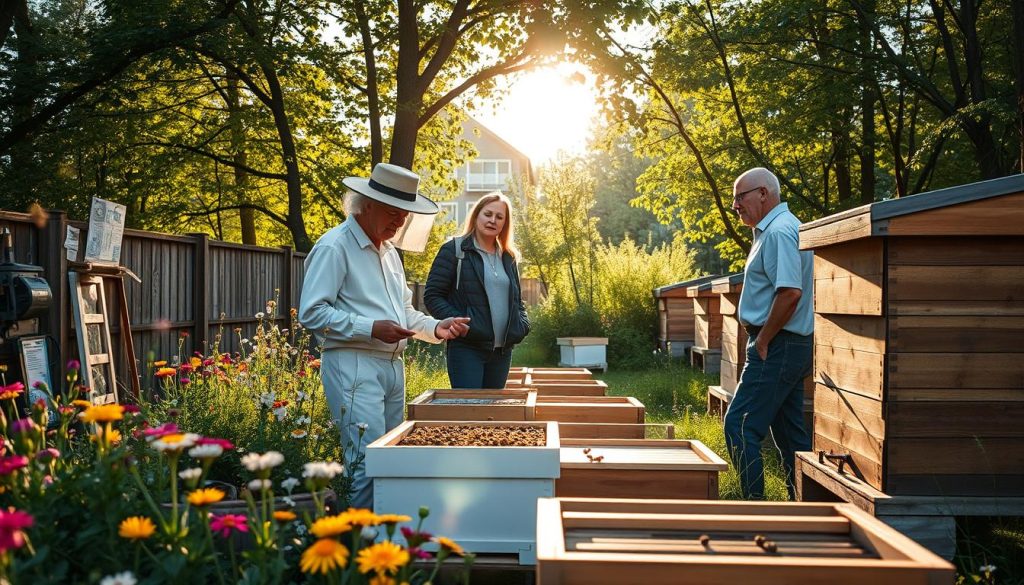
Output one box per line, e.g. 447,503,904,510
423,192,529,388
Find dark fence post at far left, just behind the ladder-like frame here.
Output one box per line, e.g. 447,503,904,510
39,209,69,370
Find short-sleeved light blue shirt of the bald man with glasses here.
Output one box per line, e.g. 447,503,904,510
739,203,814,335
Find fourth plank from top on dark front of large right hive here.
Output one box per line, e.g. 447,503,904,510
887,347,1024,388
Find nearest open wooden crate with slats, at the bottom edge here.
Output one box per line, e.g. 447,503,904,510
537,498,954,585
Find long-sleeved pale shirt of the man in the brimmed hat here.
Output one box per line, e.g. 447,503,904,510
298,217,440,356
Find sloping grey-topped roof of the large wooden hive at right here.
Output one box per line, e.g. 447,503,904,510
800,174,1024,249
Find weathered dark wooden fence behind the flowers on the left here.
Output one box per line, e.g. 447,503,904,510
0,211,543,397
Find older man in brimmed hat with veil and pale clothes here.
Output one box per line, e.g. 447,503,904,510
299,163,469,508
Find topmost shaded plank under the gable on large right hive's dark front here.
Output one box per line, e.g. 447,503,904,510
888,236,1024,266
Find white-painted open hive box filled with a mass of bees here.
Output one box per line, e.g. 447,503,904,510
366,420,560,565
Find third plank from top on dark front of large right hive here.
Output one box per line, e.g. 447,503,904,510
889,316,1024,352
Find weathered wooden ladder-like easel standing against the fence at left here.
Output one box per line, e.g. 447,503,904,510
68,262,139,405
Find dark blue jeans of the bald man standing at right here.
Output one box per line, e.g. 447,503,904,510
725,331,813,500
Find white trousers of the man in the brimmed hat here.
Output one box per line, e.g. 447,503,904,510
321,349,406,509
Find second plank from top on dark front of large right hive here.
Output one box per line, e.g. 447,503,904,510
887,265,1024,302
